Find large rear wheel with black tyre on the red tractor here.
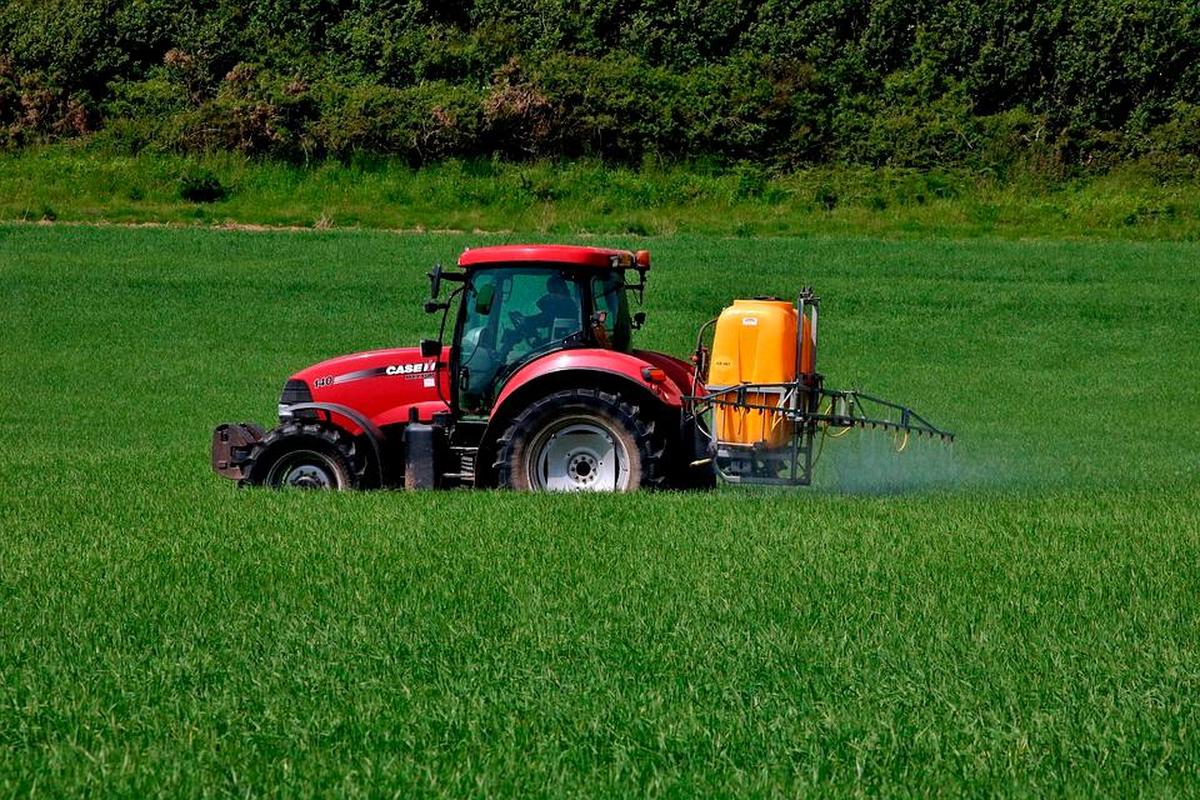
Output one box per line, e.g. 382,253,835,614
494,389,662,491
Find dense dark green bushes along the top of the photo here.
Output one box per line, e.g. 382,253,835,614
0,0,1200,176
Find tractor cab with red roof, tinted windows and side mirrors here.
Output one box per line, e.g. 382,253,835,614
426,246,649,416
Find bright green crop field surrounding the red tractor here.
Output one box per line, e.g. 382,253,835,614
0,225,1200,796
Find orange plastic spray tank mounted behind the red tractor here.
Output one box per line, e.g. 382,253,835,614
707,300,812,447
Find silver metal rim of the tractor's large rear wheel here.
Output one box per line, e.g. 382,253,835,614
526,417,629,492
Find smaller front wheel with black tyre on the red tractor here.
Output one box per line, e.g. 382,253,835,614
244,422,364,491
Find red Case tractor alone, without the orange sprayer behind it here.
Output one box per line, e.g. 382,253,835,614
214,245,713,491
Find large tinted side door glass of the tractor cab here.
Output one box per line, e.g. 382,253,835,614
458,267,583,413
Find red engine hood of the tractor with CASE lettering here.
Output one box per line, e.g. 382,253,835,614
292,348,450,426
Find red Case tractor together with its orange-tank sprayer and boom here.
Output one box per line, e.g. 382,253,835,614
212,245,953,492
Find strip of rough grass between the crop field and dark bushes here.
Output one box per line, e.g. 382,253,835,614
7,144,1200,241
